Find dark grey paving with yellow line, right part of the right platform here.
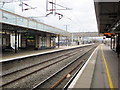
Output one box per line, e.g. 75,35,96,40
91,45,119,88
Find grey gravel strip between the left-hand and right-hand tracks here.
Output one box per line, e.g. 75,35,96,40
2,45,94,88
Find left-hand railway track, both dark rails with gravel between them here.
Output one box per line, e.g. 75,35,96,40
2,46,97,88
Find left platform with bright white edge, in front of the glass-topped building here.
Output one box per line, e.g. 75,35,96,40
0,44,91,62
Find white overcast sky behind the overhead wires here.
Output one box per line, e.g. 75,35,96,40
1,0,98,32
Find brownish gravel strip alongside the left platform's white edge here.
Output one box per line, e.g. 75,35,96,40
2,50,78,75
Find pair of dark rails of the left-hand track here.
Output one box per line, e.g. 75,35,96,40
2,49,80,86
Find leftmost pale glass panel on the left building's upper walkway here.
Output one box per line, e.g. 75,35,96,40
2,12,16,24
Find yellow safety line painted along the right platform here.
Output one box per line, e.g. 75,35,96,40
101,46,114,90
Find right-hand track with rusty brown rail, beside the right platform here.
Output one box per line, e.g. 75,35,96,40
32,44,95,90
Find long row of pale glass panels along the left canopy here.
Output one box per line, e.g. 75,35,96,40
0,11,65,34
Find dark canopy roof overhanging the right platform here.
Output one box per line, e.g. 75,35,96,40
94,0,120,34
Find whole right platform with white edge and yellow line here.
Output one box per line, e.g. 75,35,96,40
69,44,120,90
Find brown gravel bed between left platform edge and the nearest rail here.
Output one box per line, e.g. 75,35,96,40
1,47,79,76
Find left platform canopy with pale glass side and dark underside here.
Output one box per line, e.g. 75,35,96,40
0,9,70,36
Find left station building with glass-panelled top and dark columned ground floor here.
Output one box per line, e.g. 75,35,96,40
0,9,70,52
